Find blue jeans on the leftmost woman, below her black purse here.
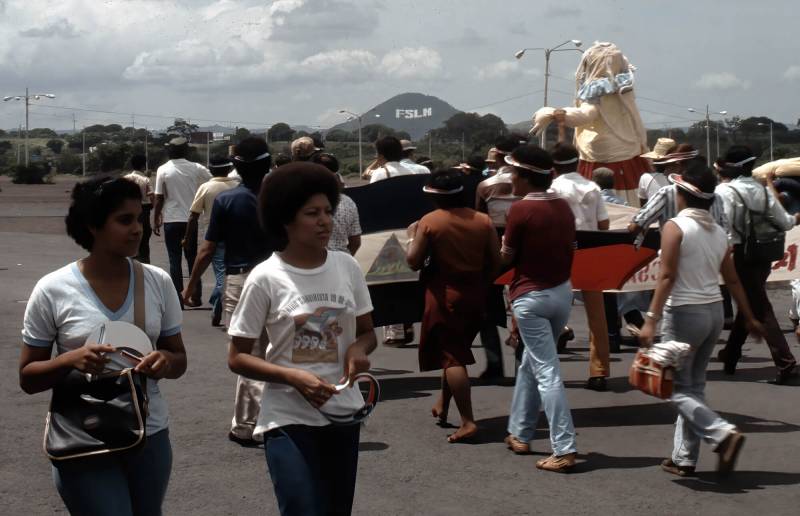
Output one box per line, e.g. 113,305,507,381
53,430,172,516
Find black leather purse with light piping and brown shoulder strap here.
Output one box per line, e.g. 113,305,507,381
44,260,148,461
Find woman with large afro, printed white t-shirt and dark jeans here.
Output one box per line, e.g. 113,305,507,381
228,162,376,515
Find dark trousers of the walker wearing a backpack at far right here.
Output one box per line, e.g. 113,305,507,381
725,245,796,371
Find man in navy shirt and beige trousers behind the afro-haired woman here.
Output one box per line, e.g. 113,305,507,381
182,138,273,446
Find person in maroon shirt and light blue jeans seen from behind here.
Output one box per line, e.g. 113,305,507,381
500,145,577,471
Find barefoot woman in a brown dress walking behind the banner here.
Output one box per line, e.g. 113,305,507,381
407,169,500,443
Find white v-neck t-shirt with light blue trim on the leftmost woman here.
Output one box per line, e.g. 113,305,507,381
22,260,183,435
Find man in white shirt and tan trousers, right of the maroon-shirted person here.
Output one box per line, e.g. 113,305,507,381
550,143,610,391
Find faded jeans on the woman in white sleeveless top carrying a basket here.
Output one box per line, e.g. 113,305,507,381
661,301,735,466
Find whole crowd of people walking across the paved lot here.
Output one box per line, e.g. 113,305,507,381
15,126,800,515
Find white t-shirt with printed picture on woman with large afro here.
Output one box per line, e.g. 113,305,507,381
228,251,372,435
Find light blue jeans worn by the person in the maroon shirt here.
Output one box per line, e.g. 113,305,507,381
508,281,577,455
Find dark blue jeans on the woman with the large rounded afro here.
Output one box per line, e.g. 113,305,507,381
264,425,361,516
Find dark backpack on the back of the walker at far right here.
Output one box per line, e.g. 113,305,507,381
728,185,786,263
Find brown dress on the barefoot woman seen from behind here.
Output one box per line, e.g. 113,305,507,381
417,208,495,371
